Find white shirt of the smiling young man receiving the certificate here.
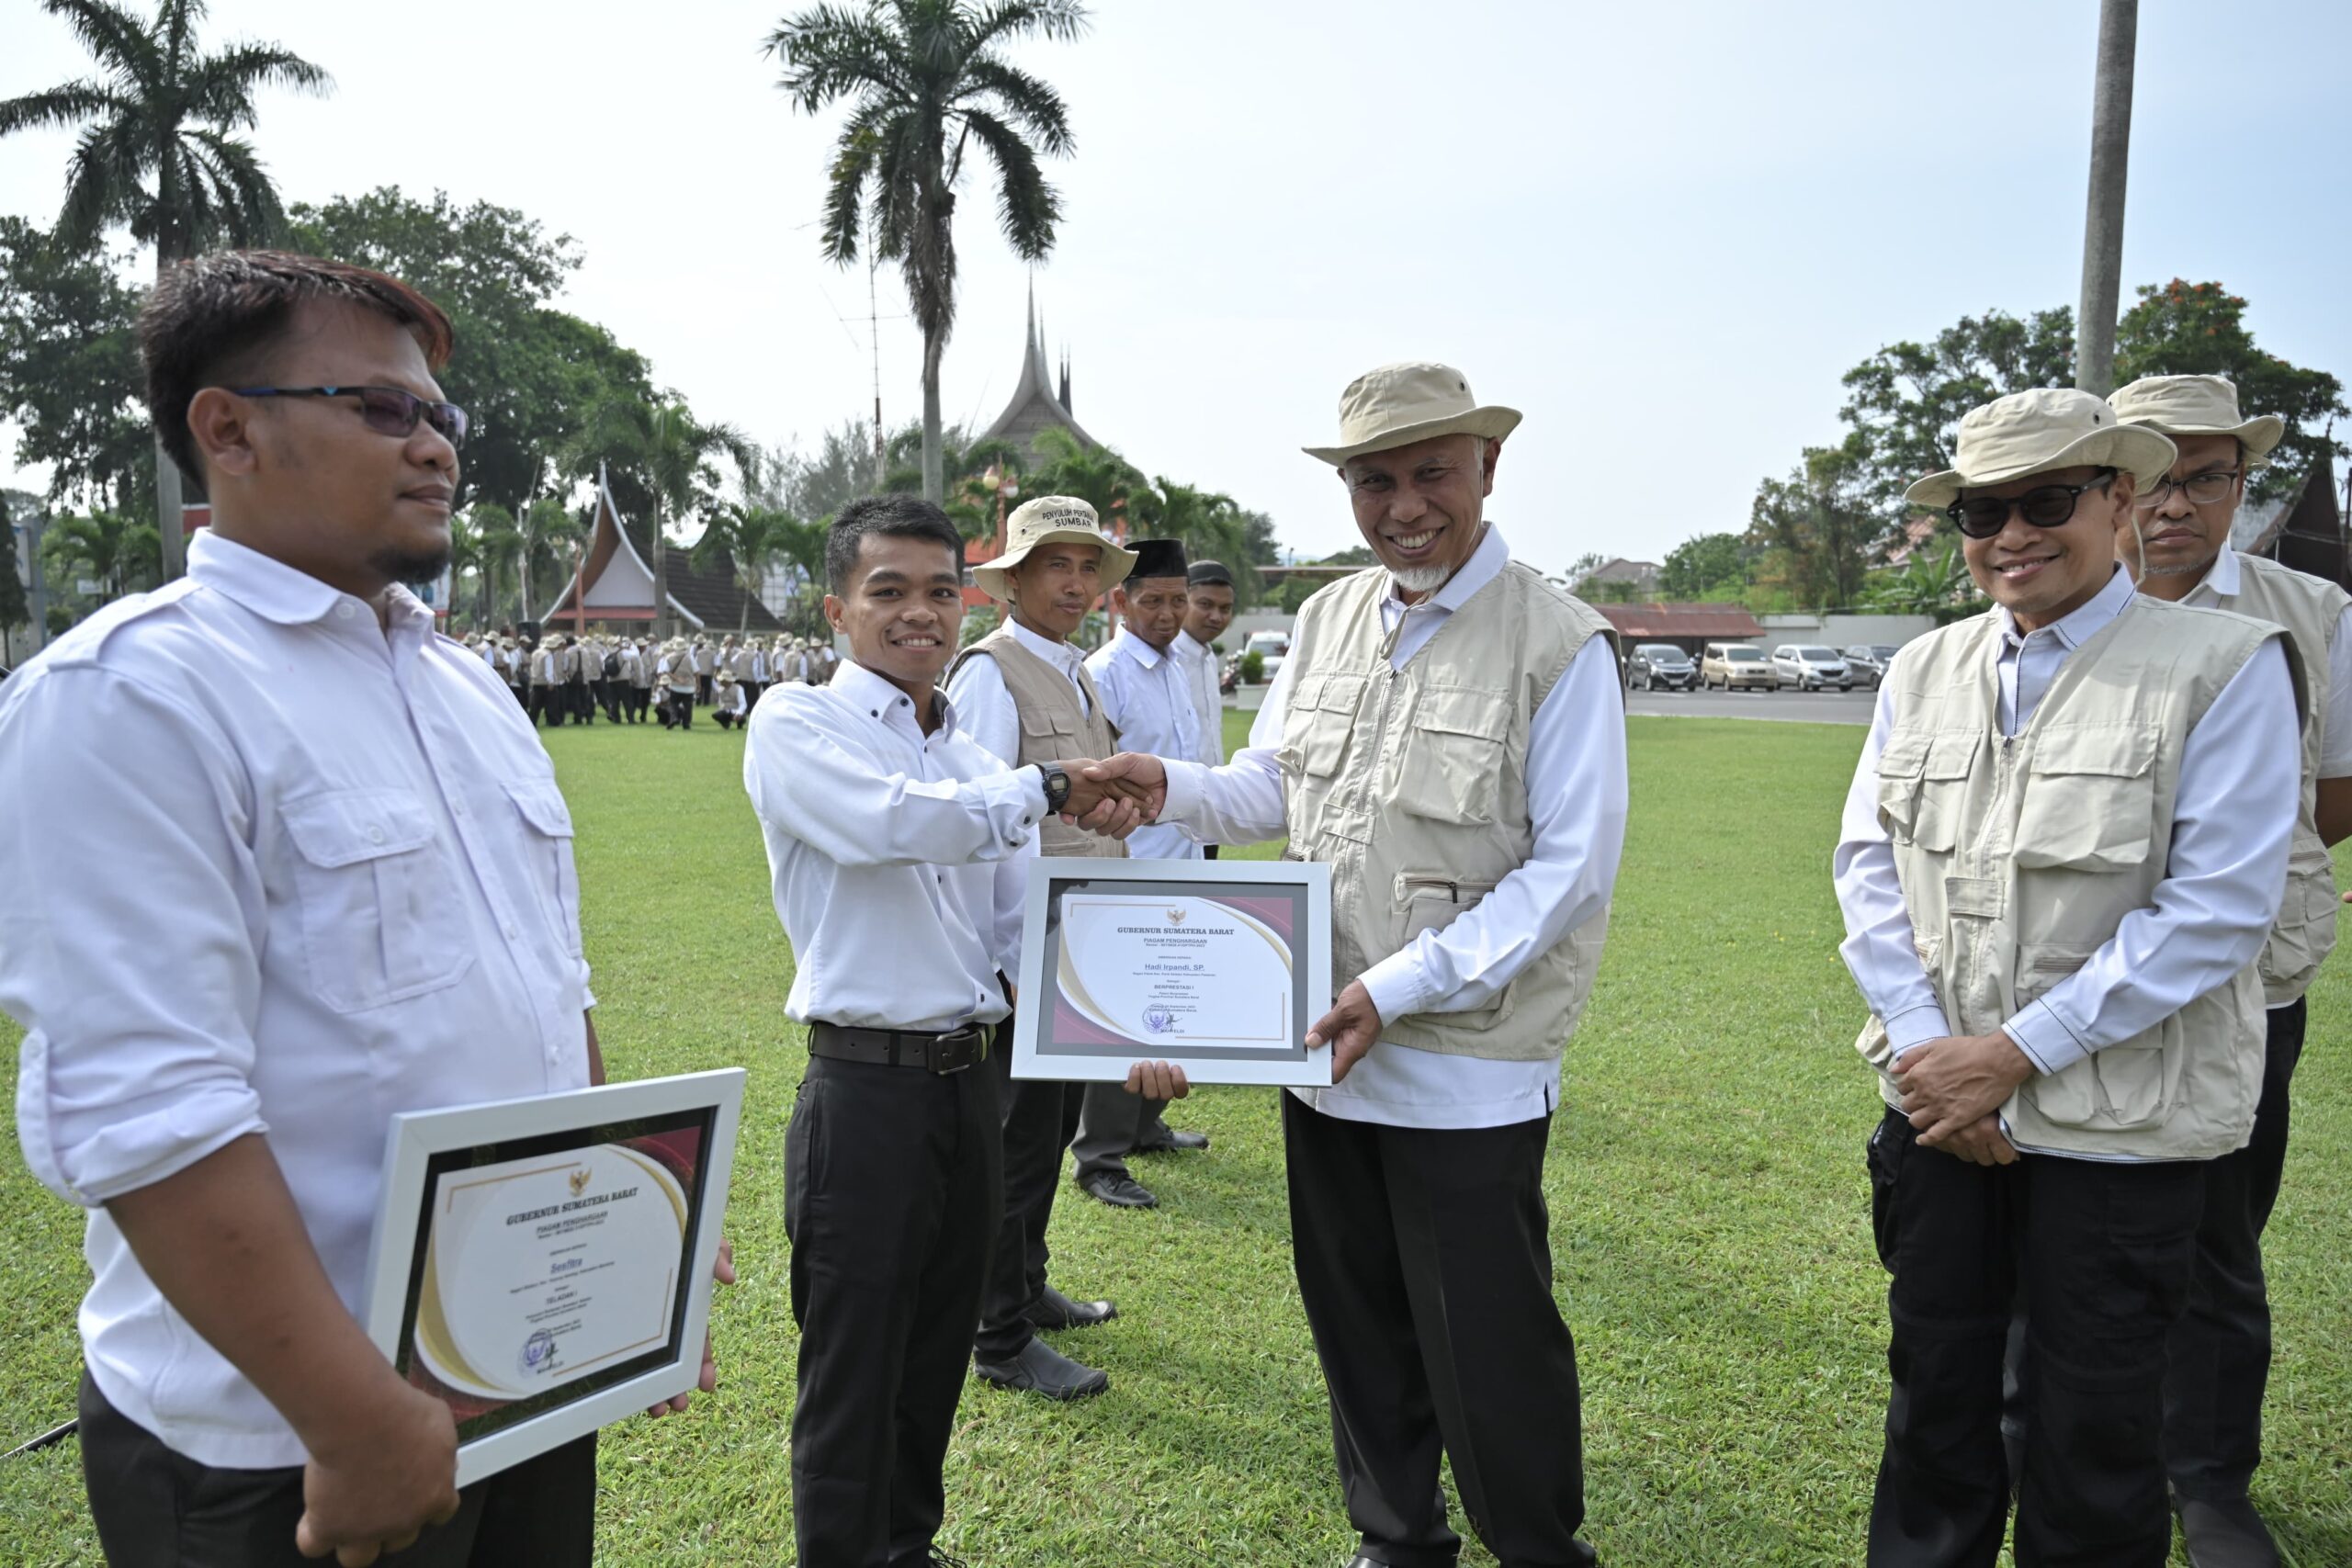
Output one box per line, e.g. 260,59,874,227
743,660,1045,1032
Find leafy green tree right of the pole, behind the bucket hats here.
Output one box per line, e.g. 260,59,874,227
2114,277,2352,501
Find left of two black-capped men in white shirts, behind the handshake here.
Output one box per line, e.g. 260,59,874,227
1070,538,1209,1208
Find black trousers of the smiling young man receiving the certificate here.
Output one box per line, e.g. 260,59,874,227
783,1055,1004,1568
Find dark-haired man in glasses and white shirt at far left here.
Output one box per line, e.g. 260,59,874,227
0,252,710,1568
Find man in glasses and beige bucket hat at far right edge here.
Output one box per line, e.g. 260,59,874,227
2109,376,2352,1568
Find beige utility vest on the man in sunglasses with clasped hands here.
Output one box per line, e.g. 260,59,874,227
1856,597,2302,1159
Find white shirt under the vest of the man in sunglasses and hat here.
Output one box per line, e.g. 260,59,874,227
1830,567,2302,1114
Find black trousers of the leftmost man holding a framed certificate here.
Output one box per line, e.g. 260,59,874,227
80,1373,595,1568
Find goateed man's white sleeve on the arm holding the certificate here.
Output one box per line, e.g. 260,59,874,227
1362,637,1628,1021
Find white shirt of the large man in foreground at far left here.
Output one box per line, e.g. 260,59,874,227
0,531,593,1470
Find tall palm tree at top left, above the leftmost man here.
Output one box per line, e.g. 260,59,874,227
0,0,334,581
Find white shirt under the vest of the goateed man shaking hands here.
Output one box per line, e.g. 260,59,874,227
1162,525,1625,1128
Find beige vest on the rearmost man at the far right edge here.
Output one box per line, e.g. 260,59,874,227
2222,555,2352,1006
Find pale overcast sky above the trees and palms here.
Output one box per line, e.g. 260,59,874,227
0,0,2352,569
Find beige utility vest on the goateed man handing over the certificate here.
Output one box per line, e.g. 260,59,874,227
1282,562,1616,1063
